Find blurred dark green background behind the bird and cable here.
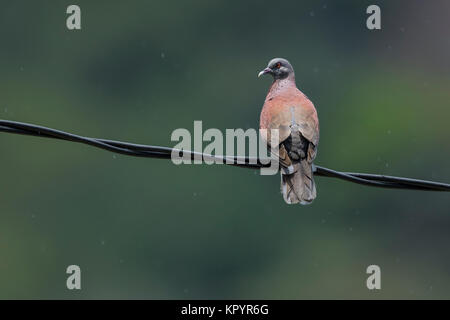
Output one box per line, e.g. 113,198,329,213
0,0,450,299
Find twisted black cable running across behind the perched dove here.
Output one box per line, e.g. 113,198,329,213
0,120,450,191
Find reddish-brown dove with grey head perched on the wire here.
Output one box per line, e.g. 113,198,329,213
258,58,320,205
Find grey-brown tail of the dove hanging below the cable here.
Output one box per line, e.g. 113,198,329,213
281,159,316,204
